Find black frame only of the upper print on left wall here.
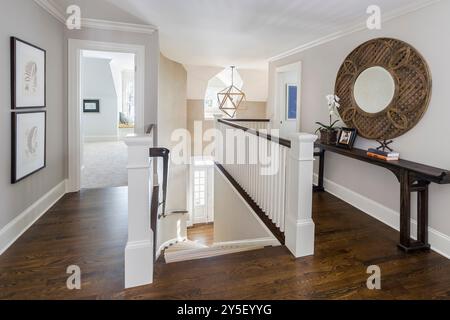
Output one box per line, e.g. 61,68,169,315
10,37,47,110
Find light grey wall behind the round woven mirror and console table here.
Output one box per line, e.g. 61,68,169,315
268,1,450,255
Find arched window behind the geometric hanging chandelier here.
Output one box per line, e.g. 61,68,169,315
205,68,244,119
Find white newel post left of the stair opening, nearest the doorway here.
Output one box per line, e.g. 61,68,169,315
125,135,154,288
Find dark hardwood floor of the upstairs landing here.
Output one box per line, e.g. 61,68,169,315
0,188,450,300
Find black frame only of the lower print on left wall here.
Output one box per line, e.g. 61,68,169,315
11,110,47,184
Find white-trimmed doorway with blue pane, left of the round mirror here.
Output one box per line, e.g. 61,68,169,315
275,62,302,138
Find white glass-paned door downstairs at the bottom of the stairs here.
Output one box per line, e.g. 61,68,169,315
192,167,214,224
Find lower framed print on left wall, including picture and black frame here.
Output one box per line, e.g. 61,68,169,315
11,111,47,184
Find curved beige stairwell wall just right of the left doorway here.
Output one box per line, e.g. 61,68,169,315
158,55,188,210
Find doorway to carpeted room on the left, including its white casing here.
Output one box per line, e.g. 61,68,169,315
67,39,145,192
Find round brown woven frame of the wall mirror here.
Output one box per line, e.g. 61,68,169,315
335,38,432,140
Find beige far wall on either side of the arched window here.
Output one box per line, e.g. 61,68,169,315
187,100,267,156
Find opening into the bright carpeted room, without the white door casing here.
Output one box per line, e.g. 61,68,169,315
80,50,136,189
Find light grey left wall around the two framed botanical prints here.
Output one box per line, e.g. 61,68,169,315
0,0,67,230
